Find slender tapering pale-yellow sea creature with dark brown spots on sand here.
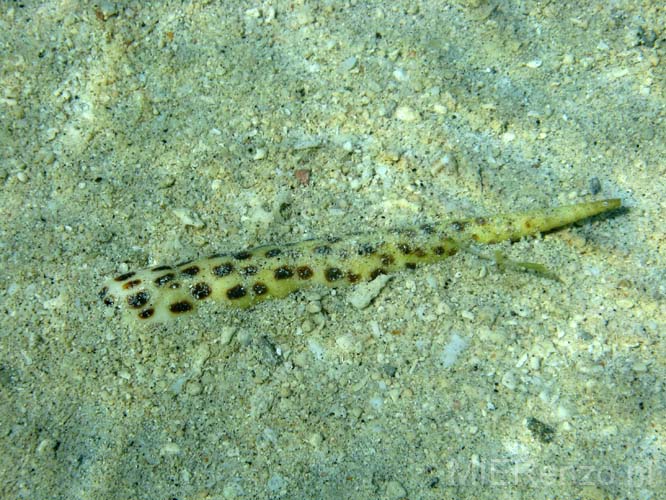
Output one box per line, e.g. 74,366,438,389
99,199,621,323
